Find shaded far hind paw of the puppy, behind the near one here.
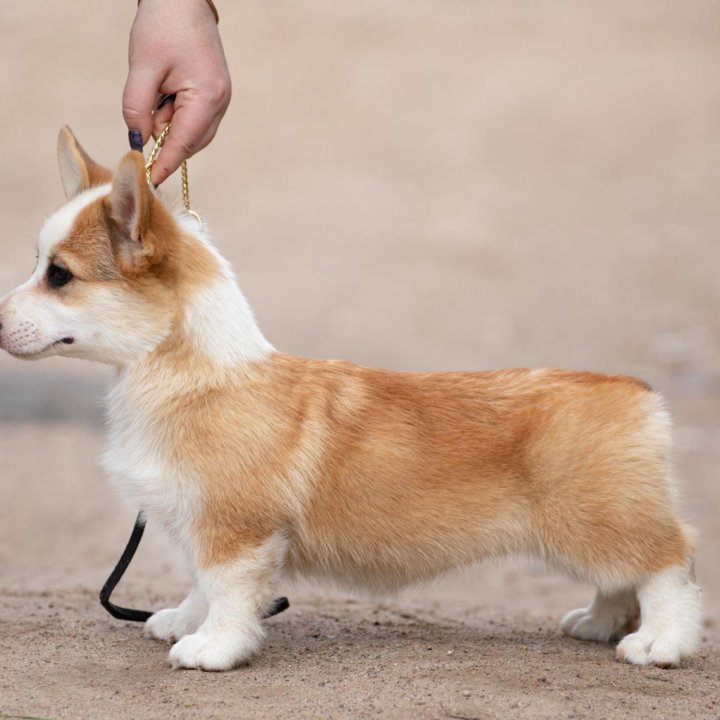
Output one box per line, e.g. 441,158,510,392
560,590,640,642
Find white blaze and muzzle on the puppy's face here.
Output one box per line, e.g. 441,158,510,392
0,184,110,359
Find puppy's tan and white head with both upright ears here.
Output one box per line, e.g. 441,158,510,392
0,128,217,366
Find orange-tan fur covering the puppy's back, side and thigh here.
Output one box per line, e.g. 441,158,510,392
138,354,690,586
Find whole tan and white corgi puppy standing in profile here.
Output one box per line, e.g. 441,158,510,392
0,128,701,670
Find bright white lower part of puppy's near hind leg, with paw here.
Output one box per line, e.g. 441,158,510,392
617,566,702,667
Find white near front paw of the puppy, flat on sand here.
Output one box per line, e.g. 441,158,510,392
168,631,262,671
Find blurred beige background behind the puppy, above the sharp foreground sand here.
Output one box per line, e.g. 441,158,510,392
0,0,720,656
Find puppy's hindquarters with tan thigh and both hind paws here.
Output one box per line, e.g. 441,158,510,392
539,393,701,667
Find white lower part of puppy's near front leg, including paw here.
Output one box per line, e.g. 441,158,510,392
169,535,286,670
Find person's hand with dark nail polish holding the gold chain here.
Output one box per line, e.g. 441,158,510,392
123,0,231,185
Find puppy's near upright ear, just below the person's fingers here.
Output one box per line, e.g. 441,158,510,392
105,150,158,275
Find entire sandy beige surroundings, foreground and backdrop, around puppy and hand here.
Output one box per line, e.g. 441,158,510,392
0,0,720,720
